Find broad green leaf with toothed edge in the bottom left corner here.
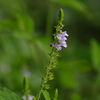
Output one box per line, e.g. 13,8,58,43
0,88,21,100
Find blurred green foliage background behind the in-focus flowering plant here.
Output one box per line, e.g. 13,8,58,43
0,0,100,100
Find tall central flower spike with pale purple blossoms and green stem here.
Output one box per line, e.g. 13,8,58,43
36,9,69,100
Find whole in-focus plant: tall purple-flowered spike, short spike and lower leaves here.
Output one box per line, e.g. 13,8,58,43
0,9,69,100
